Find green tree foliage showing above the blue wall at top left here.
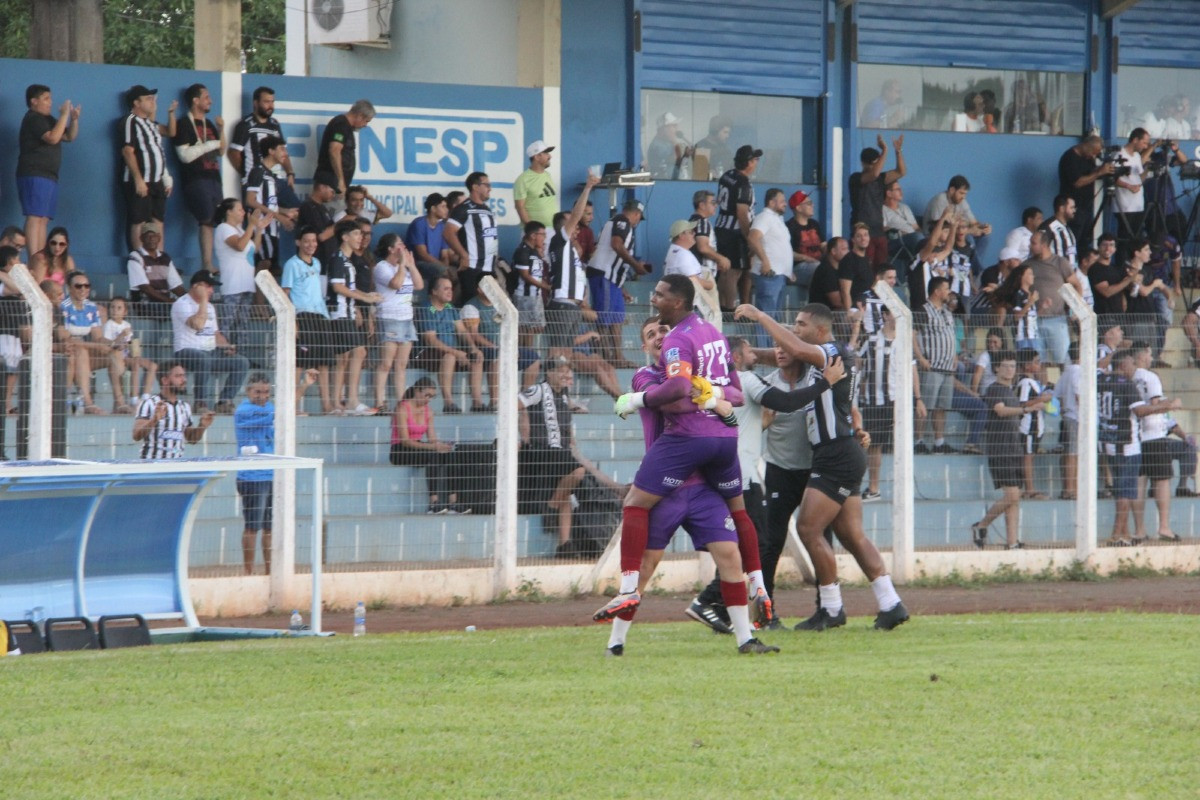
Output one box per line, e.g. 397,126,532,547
0,0,284,74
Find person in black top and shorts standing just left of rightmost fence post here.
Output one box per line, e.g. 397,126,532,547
971,350,1032,551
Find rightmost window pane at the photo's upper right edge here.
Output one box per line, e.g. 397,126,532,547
1117,66,1200,142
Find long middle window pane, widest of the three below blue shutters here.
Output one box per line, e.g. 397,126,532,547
858,64,1084,134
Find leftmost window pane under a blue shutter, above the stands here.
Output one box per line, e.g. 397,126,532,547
642,89,817,184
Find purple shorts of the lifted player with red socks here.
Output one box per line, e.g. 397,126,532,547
634,433,742,498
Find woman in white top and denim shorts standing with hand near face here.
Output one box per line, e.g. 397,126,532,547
373,234,425,413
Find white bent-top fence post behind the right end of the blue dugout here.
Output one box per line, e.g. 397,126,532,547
254,270,297,609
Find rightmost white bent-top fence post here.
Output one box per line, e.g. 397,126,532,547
1058,284,1100,561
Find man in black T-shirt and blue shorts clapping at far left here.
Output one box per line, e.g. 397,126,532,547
17,83,82,253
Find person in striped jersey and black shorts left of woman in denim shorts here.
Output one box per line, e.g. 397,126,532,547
326,219,383,416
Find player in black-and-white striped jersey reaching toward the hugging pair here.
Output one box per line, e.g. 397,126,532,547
734,302,908,631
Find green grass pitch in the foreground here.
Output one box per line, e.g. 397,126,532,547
0,613,1200,800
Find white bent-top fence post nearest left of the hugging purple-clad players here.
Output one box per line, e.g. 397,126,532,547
479,276,521,597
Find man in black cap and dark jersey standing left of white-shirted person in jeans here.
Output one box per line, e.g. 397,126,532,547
713,144,762,311
